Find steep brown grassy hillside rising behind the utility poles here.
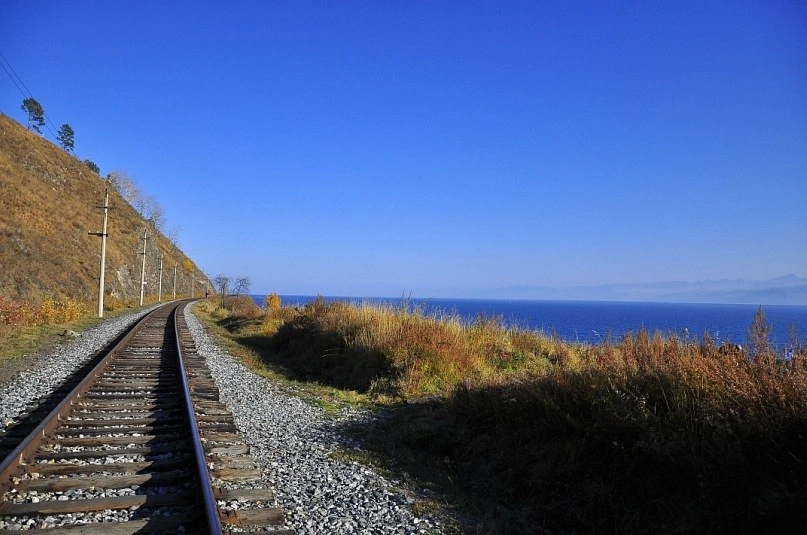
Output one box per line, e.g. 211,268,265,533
0,114,209,302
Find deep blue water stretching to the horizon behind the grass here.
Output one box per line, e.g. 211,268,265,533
253,295,807,348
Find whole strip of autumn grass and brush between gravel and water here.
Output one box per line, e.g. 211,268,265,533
214,299,807,533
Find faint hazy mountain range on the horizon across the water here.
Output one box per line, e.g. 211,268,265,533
476,275,807,305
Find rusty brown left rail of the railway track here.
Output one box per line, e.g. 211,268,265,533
0,303,176,495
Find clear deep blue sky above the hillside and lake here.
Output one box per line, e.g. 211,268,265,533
0,0,807,297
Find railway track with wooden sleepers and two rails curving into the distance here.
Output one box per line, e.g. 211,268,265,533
0,302,291,535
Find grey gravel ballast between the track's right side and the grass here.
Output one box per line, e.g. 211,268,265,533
185,307,443,535
